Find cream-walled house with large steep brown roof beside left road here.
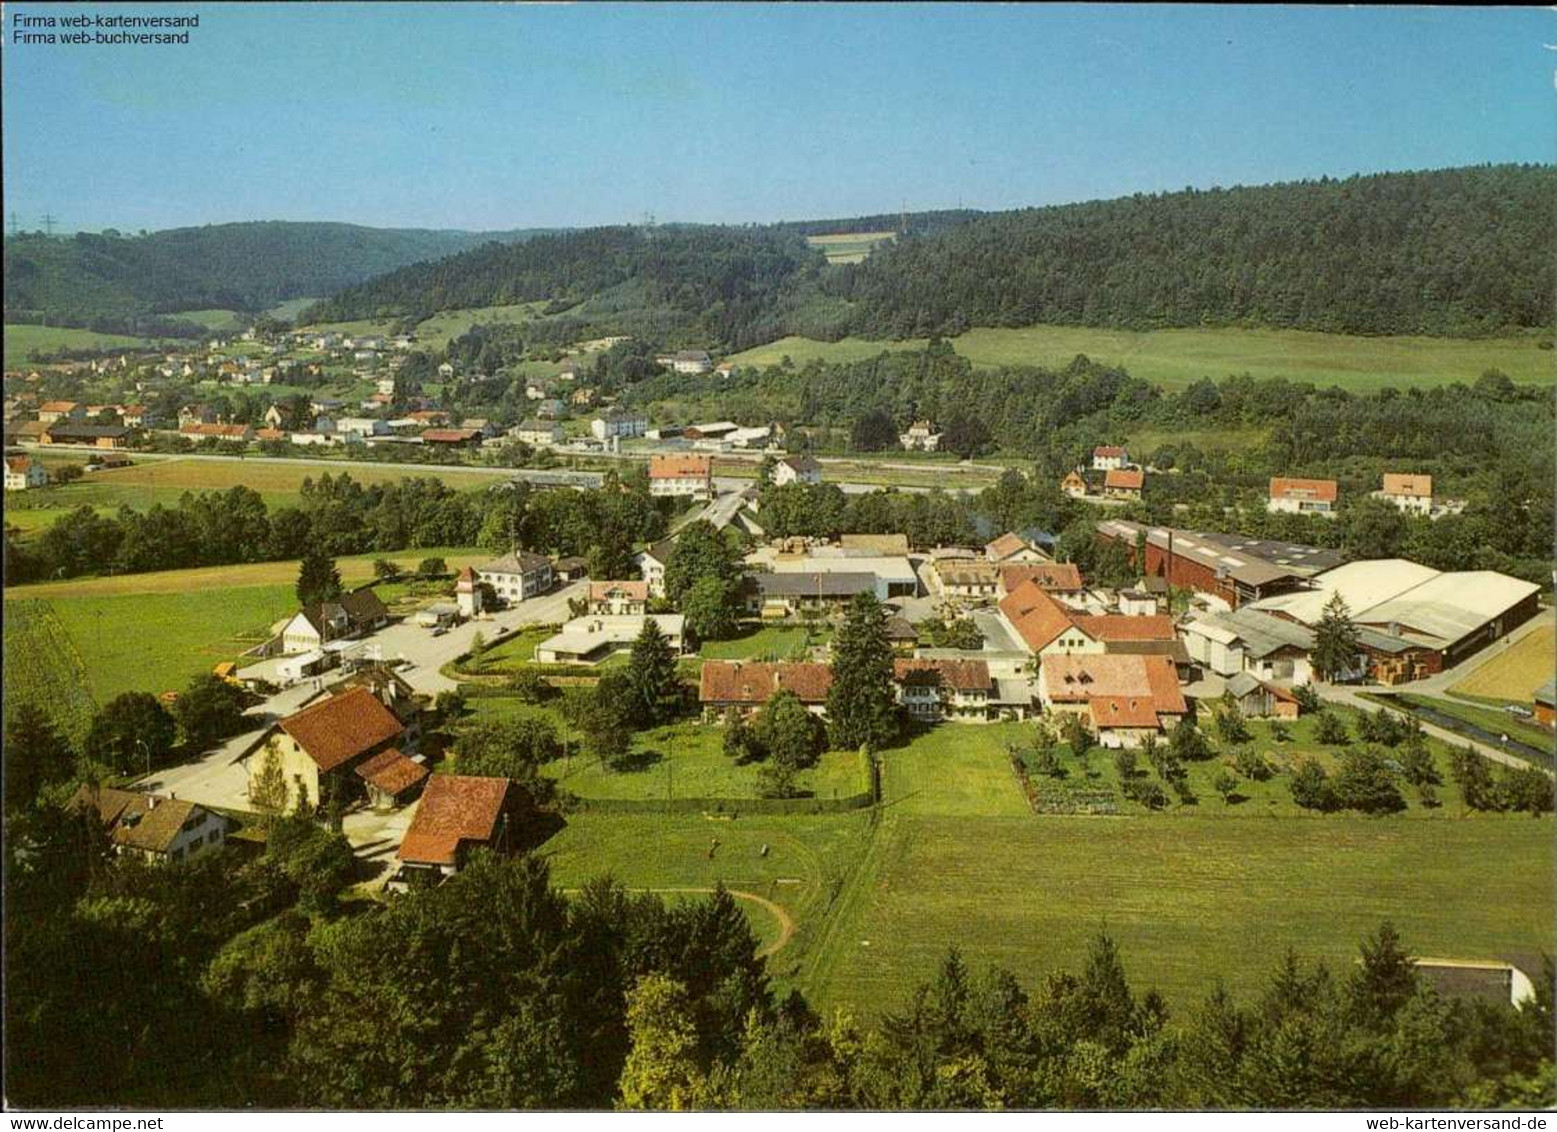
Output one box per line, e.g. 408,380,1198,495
241,687,405,811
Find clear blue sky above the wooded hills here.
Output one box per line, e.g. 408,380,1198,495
3,3,1557,230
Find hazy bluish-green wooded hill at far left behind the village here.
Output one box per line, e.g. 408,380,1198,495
5,221,548,329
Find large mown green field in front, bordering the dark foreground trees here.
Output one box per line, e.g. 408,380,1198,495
526,710,1557,1014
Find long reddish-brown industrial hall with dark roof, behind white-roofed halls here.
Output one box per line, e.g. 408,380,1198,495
1098,519,1344,607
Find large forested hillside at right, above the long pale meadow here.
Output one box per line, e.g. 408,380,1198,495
825,165,1557,338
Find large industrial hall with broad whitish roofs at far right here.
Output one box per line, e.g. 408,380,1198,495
1255,559,1540,684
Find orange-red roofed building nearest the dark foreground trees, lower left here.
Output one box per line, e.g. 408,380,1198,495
388,774,526,889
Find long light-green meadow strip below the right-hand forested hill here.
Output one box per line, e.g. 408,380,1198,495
732,325,1554,391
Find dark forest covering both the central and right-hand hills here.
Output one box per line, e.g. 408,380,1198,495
294,165,1557,342
